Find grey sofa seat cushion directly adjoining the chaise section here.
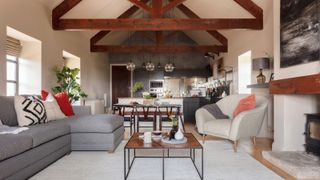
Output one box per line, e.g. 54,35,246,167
21,120,70,147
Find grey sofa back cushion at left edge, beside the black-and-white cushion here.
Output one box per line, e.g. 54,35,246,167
0,96,18,126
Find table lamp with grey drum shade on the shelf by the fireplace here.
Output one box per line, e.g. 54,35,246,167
252,57,270,84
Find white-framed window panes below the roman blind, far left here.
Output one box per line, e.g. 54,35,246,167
7,55,19,96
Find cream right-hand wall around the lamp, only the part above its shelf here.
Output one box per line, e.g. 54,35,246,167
221,0,273,93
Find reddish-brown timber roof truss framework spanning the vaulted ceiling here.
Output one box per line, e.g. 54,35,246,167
52,0,263,54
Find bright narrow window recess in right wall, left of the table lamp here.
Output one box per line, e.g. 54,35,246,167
238,51,252,94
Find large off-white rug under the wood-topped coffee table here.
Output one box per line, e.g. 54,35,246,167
31,141,281,180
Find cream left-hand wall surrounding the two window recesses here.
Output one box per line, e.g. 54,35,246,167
0,0,108,99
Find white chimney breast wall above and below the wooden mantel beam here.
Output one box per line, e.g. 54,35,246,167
272,0,320,151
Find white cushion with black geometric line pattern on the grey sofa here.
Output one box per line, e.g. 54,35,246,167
14,96,48,126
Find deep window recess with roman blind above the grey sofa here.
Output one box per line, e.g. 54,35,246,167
6,26,41,96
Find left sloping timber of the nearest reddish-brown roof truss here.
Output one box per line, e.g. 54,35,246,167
52,0,81,26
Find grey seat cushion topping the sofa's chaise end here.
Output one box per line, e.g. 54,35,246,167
66,114,123,133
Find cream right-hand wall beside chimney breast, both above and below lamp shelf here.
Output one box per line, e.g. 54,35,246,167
220,0,274,138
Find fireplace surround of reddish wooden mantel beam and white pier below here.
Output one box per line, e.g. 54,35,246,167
270,73,320,151
